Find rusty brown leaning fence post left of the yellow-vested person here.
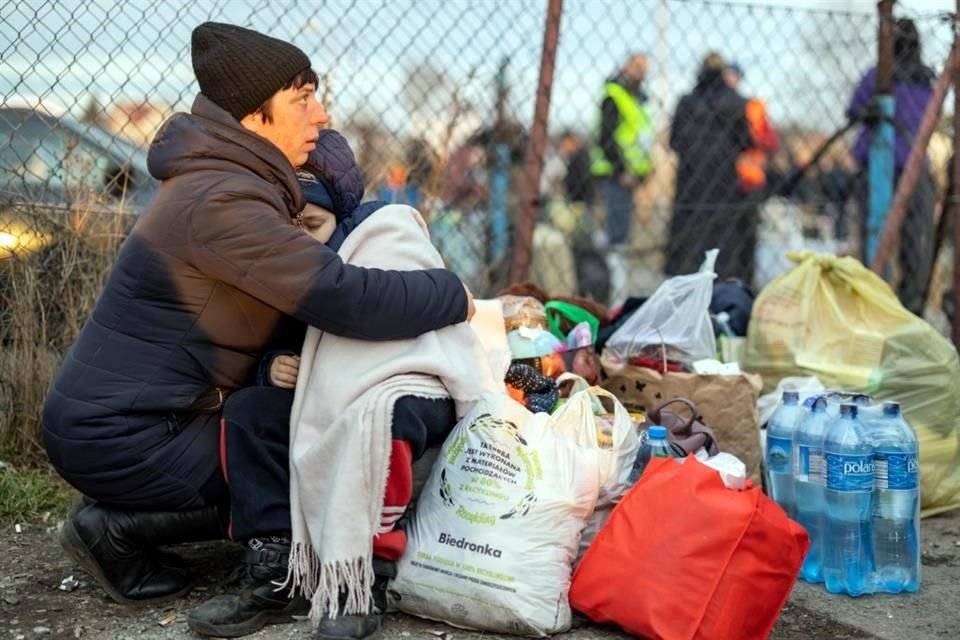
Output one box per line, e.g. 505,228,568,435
510,0,563,282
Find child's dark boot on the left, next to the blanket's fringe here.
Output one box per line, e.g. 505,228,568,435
187,542,310,638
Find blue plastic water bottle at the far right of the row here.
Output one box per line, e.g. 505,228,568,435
867,402,920,593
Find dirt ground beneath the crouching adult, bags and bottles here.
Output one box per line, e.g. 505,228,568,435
0,512,960,640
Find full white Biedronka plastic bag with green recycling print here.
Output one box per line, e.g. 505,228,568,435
390,395,600,636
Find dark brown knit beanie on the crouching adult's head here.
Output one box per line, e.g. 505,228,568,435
191,22,310,120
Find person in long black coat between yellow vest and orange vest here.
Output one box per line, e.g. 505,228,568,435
666,53,757,282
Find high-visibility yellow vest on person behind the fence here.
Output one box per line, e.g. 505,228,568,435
590,82,653,176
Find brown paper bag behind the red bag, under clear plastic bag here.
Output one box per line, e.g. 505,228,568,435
600,351,763,482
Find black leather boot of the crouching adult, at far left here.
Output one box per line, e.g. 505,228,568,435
60,503,223,604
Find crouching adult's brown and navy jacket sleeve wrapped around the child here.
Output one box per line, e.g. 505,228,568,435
191,191,468,340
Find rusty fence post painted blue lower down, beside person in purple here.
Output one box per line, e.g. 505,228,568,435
865,0,894,264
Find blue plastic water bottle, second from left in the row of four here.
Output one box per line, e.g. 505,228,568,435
793,397,831,582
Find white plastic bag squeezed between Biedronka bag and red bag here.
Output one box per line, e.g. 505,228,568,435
553,374,640,561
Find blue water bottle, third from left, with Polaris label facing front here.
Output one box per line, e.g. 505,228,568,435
823,404,873,596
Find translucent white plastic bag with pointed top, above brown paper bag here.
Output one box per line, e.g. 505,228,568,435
607,249,717,362
